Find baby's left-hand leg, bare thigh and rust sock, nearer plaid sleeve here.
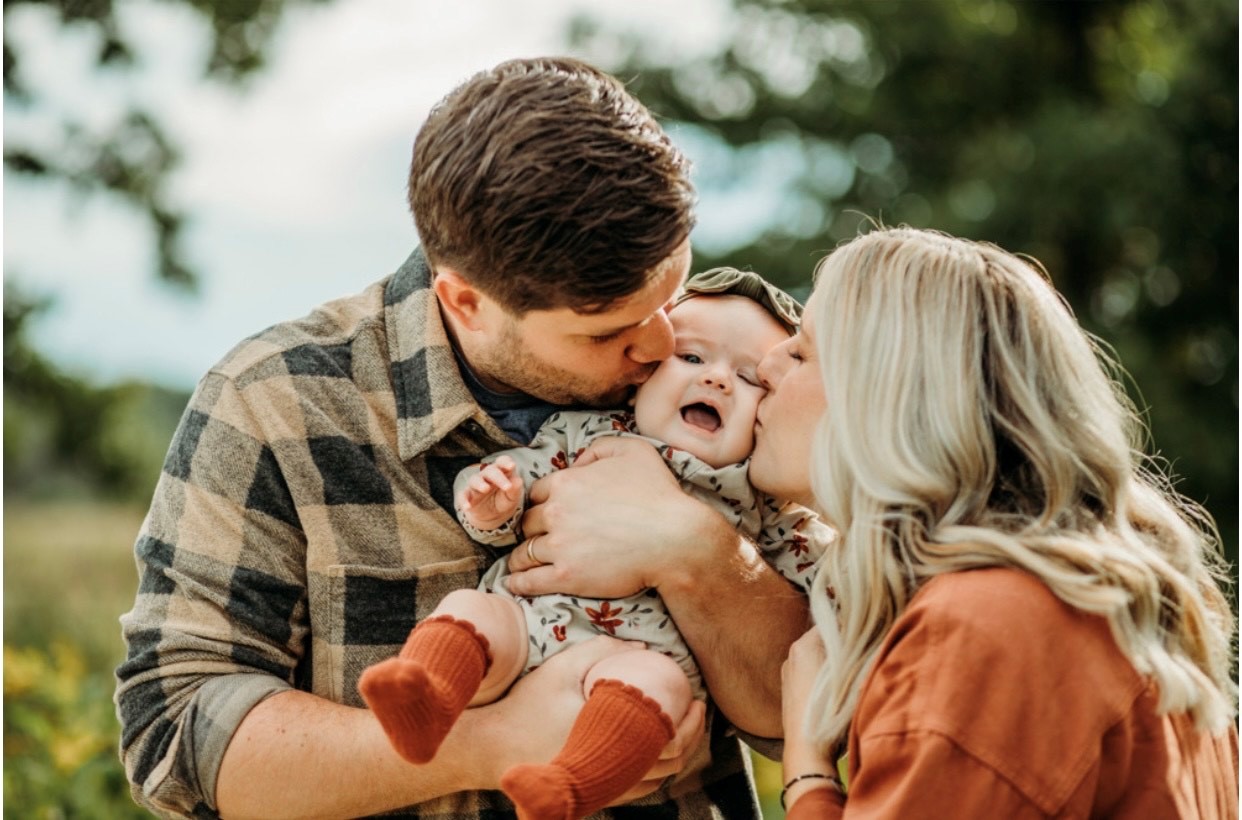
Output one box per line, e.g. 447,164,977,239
358,589,527,763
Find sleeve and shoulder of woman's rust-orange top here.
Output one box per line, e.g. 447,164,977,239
799,570,1141,820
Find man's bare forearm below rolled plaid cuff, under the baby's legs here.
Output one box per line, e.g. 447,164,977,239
216,637,640,820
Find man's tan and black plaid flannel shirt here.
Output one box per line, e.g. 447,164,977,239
116,250,759,818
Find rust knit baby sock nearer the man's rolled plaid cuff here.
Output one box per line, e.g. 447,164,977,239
358,615,492,763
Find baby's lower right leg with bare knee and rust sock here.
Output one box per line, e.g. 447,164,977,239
501,650,692,820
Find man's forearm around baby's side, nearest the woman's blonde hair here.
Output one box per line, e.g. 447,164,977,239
660,518,810,738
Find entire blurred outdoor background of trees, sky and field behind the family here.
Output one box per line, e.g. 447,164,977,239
4,0,1238,819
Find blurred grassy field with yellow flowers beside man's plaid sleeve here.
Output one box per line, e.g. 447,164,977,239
4,502,784,820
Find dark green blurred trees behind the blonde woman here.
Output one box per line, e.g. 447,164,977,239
574,0,1238,559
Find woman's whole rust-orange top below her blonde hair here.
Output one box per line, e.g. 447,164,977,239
787,569,1238,820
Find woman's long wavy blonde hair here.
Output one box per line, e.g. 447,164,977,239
807,227,1237,752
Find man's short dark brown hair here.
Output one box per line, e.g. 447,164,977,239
409,57,694,316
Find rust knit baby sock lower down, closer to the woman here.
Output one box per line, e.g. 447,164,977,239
501,680,673,820
